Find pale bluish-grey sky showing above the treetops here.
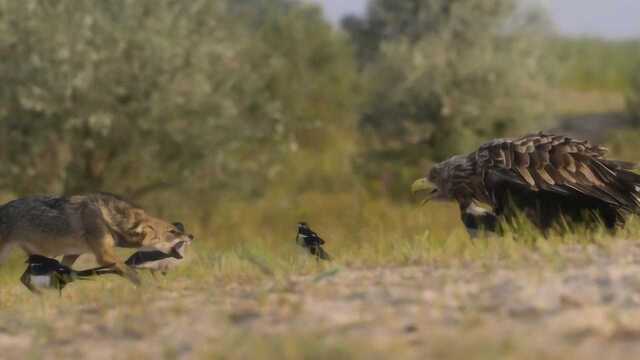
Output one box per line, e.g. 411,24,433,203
307,0,640,39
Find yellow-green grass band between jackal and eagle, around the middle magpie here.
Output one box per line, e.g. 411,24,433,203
0,194,638,296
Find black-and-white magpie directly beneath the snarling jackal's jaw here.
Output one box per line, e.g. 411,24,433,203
125,223,193,277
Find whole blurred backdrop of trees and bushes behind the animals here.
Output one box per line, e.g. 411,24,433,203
0,0,640,248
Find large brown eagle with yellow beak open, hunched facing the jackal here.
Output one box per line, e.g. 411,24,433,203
412,133,640,235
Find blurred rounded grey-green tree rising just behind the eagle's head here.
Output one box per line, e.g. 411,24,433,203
343,0,547,160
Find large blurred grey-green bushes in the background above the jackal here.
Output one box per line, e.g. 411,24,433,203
0,0,357,202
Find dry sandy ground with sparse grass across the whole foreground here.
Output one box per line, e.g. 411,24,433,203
0,241,640,359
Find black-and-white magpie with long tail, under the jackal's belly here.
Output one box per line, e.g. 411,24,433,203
20,255,113,295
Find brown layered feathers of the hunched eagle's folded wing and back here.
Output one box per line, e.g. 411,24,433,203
476,133,640,210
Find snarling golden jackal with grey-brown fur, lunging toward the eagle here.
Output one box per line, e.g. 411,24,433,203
0,193,193,284
